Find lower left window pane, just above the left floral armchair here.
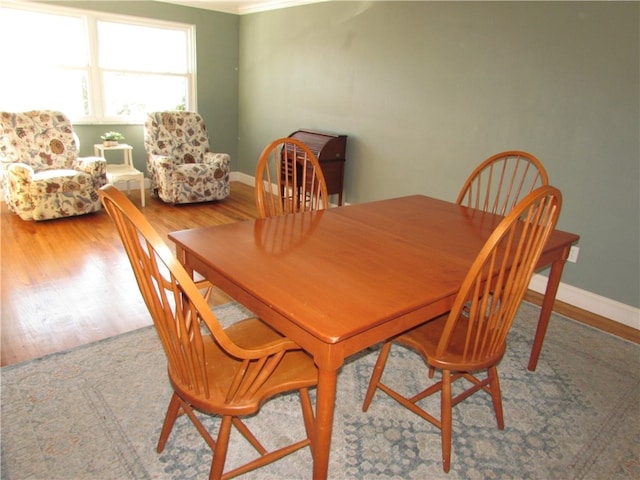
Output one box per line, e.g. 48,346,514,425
0,68,90,118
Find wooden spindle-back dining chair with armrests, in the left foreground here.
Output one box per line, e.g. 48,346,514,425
99,185,318,479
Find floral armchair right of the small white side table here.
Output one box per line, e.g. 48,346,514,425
144,111,231,204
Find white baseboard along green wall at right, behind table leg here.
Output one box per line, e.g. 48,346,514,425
529,274,640,330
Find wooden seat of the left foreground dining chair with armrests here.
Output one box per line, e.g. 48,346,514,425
169,318,318,416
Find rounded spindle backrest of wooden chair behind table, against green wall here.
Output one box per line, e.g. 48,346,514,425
456,150,549,215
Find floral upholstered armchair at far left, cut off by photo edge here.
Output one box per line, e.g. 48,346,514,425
0,110,107,220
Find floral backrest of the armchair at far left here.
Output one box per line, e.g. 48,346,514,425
0,110,78,171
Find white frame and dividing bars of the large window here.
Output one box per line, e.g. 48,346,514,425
0,1,197,125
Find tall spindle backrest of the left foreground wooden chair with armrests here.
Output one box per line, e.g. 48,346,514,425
99,185,246,398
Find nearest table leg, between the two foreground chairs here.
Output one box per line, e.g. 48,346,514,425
313,367,338,480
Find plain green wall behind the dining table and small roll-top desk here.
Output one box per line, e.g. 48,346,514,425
238,2,640,307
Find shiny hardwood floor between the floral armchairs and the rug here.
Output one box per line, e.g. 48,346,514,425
0,182,257,366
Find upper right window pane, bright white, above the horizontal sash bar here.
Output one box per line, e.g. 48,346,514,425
98,22,188,73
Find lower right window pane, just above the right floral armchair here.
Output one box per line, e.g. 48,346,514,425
103,73,188,120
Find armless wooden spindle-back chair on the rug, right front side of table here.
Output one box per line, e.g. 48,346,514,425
362,186,562,472
